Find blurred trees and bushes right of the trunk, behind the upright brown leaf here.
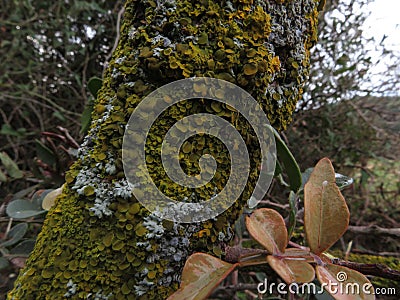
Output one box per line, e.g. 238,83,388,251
284,0,400,264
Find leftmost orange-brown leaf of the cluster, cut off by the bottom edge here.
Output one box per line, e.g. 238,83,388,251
168,253,237,300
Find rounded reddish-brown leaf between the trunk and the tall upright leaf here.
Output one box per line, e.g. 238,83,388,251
246,208,288,254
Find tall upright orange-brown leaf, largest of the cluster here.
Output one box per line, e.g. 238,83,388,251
304,158,350,255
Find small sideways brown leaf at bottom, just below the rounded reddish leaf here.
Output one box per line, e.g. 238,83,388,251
267,255,315,284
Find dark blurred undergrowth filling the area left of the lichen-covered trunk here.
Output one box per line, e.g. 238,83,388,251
0,0,123,299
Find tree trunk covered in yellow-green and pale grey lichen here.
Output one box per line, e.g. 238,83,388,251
9,0,319,299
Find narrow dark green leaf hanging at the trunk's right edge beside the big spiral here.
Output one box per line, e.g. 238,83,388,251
274,129,301,192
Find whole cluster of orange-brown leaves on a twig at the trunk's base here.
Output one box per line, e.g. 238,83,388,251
168,158,374,300
